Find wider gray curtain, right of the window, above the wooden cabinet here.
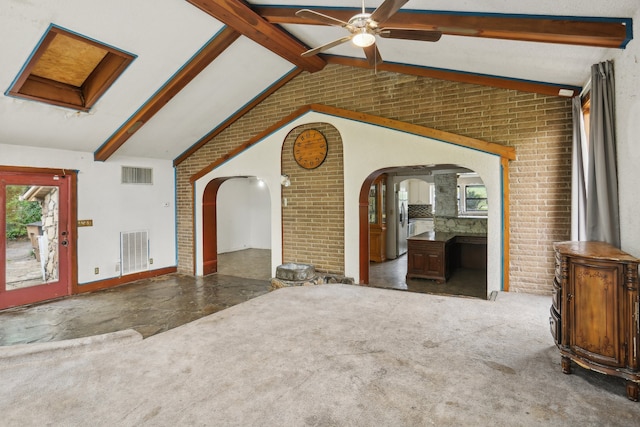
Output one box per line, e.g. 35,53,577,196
586,61,620,248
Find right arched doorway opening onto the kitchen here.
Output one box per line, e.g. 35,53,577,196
359,164,488,298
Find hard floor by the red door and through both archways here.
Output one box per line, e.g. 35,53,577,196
0,249,486,346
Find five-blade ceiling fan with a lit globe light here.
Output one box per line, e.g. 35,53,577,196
296,0,442,66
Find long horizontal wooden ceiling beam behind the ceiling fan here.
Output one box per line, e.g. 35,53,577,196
253,6,632,48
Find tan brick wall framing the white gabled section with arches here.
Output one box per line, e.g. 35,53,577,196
177,65,571,293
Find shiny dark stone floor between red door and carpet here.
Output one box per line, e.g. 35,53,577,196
0,274,270,345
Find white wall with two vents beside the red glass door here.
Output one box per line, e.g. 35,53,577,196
0,144,176,284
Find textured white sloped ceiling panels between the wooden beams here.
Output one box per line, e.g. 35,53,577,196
0,0,640,159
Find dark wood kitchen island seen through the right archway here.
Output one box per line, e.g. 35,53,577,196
406,231,487,283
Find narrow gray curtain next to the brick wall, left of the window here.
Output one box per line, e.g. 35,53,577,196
571,96,589,241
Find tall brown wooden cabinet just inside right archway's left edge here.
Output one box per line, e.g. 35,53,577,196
369,174,387,262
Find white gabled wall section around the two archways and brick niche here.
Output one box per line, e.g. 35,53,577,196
194,112,503,293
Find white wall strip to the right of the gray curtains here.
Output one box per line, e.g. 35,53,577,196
612,6,640,257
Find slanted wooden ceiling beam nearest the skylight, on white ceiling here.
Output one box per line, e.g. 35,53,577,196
93,27,240,161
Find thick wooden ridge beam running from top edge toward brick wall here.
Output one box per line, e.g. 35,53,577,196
187,0,327,73
